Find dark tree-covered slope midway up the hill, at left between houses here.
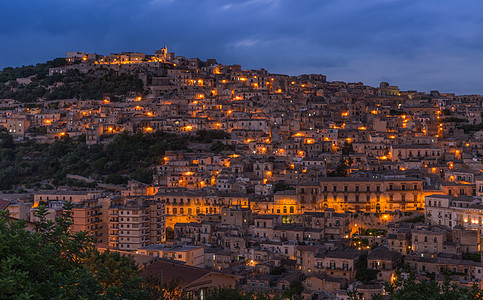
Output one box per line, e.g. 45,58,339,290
0,131,187,190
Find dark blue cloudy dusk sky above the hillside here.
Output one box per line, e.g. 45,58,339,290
0,0,483,94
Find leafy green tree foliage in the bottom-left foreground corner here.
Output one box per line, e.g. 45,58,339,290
0,203,146,299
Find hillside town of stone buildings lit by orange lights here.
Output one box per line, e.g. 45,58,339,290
0,47,483,299
